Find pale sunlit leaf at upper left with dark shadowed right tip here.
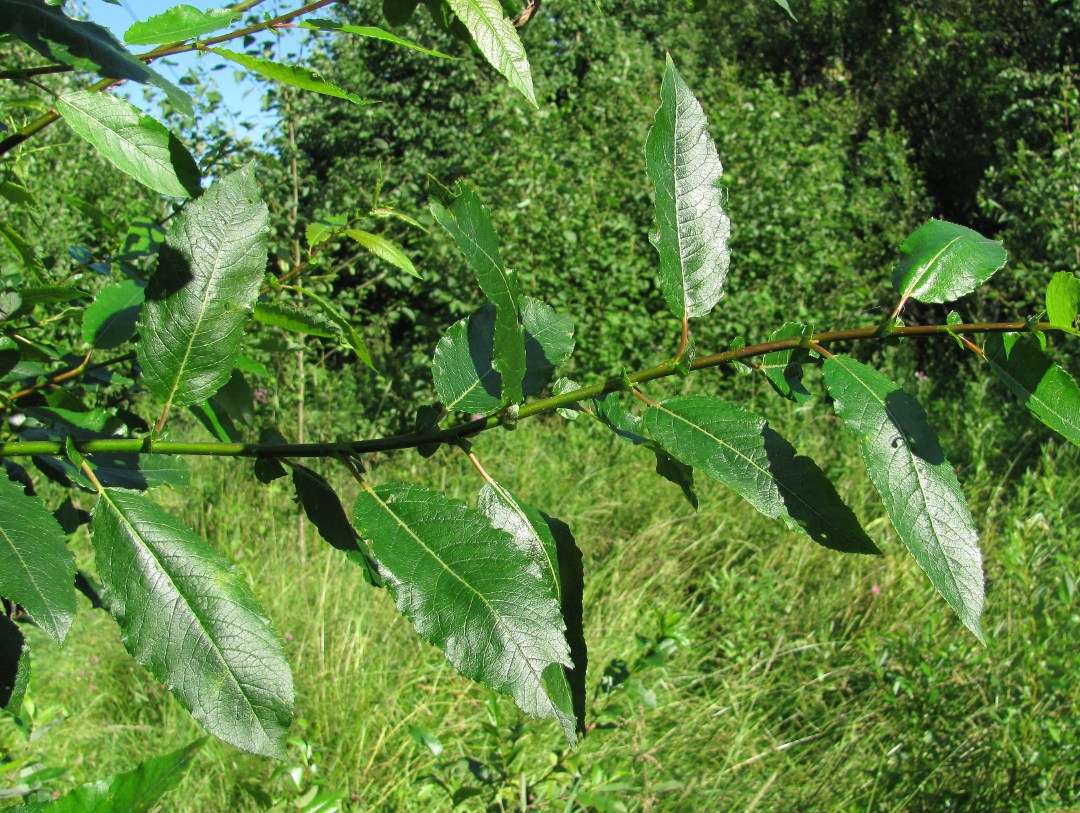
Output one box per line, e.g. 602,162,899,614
56,91,202,198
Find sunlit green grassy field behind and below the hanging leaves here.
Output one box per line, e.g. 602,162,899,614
0,390,1080,811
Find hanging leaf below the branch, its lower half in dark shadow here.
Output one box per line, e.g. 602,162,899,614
643,395,878,553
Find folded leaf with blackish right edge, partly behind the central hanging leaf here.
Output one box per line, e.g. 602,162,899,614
476,483,585,746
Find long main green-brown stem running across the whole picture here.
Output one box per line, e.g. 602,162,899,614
0,322,1063,458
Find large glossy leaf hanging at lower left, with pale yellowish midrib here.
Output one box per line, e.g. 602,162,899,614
92,489,293,758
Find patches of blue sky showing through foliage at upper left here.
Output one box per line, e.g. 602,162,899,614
85,0,308,141
